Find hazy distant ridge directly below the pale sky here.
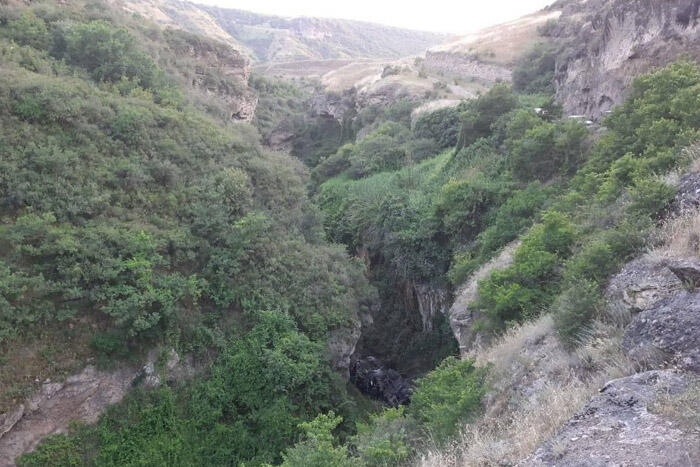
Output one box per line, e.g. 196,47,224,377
199,6,446,62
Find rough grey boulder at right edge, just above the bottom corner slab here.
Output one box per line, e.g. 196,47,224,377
622,292,700,372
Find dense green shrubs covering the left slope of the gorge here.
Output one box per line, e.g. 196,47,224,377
0,2,373,465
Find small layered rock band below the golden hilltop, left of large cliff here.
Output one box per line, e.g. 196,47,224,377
423,51,511,83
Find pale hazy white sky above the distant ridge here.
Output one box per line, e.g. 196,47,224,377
194,0,553,33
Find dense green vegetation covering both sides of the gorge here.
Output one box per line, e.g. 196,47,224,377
0,2,700,466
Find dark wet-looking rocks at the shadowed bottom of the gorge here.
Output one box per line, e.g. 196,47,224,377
350,357,411,407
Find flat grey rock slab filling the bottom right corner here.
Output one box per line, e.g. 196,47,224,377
522,370,700,467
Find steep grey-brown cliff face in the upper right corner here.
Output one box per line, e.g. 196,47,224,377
551,0,700,119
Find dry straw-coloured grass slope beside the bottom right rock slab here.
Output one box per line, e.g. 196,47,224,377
417,315,633,467
